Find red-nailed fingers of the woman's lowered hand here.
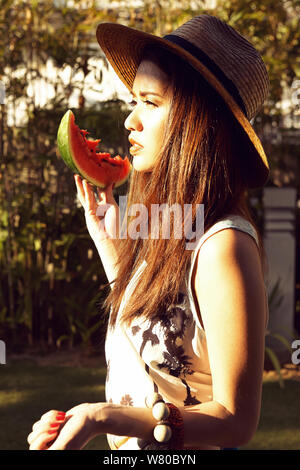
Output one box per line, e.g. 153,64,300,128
27,410,66,450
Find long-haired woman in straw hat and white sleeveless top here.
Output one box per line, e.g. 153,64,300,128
28,15,268,450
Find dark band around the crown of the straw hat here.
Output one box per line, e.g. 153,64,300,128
163,34,247,116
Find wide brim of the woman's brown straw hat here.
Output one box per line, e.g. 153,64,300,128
96,23,269,188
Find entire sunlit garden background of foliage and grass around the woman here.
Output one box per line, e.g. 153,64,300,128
0,0,300,449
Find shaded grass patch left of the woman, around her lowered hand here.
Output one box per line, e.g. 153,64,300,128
0,354,109,450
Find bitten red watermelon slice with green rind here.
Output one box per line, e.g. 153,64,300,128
57,110,132,188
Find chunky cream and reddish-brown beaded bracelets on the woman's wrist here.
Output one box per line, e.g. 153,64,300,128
139,393,184,450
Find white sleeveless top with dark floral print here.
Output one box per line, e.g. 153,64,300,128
105,215,268,450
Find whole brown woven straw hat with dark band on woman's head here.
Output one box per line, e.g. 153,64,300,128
97,14,269,188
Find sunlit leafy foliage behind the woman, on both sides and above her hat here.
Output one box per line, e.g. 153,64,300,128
0,0,300,349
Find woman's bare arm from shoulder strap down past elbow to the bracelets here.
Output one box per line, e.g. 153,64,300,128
177,229,266,446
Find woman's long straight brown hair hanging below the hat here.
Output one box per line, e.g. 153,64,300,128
105,48,262,326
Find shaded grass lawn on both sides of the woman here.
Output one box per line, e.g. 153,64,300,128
0,359,300,450
